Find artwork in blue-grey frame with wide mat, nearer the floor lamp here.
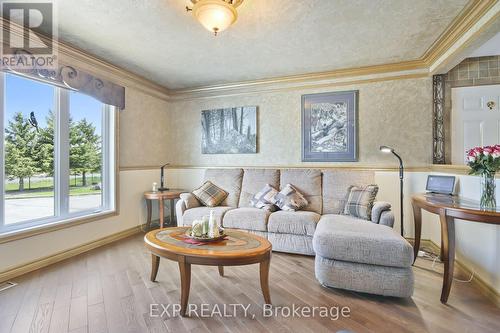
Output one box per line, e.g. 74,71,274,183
302,90,358,162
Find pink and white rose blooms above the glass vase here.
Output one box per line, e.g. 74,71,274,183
467,145,500,176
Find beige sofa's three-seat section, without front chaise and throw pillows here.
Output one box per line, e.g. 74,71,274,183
176,169,394,255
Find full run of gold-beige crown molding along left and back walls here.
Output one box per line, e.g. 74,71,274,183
0,0,500,101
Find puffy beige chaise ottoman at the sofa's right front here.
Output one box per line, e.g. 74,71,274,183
313,214,414,297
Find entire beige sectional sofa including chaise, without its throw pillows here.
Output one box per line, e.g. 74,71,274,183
176,168,414,297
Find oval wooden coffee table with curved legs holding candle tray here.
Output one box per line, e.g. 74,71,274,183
144,227,272,316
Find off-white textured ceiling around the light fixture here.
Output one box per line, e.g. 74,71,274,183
52,0,467,89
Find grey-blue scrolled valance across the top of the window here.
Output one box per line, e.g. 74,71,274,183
3,59,125,109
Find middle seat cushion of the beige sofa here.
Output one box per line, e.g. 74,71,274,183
222,207,271,231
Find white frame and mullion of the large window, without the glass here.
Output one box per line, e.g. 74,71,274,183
0,72,119,237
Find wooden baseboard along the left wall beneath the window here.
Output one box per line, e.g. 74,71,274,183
0,225,143,283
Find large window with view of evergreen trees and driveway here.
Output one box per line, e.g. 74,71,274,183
0,74,115,233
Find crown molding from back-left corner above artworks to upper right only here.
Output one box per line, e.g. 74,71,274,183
169,0,499,100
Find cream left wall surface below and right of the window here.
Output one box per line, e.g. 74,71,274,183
0,87,169,272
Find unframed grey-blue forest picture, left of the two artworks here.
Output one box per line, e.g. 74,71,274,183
201,106,257,154
